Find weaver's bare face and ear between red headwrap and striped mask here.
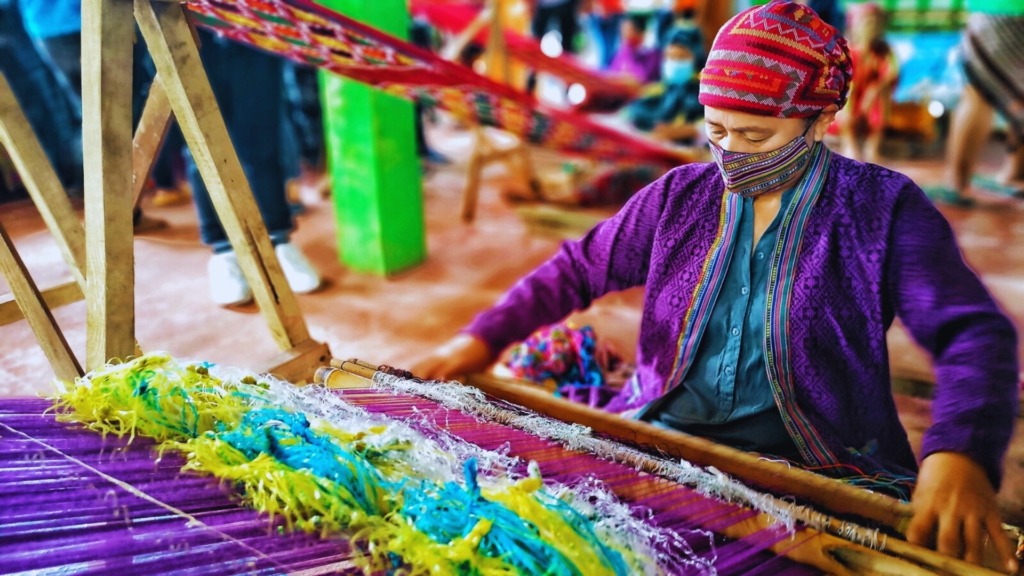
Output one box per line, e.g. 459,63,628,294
705,105,838,153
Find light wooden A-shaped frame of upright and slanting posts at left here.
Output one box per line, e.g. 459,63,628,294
0,0,330,382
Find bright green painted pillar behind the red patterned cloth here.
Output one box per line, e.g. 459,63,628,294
318,0,427,275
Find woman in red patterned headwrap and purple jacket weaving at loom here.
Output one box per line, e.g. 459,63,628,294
417,0,1018,569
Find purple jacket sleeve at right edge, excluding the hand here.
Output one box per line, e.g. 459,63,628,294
887,182,1019,490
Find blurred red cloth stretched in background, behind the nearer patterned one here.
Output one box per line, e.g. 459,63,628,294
412,0,640,100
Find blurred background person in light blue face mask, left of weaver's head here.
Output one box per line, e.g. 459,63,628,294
628,28,706,142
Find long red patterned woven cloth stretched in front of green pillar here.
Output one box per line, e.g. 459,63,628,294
187,0,683,166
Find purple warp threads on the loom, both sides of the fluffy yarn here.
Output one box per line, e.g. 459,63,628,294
0,360,817,575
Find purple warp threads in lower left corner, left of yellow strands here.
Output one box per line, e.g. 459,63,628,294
0,399,356,575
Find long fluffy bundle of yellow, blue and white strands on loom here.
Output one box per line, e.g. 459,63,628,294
53,354,659,576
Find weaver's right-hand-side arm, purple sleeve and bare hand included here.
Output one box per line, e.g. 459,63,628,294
887,183,1019,570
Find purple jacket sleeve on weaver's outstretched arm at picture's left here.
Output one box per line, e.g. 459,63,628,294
464,166,678,354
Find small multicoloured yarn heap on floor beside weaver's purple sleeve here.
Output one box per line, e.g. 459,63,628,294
505,323,622,407
